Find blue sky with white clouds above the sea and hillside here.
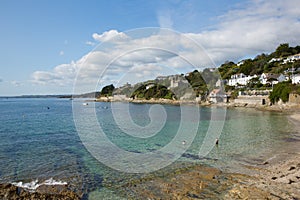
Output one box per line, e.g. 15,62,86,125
0,0,300,96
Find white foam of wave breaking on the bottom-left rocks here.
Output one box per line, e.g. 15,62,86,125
12,178,68,191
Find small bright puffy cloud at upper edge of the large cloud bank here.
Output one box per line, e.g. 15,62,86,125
93,30,128,42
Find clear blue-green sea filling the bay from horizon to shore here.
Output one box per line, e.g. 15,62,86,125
0,98,296,199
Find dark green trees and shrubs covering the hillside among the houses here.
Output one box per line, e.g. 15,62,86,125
101,43,300,103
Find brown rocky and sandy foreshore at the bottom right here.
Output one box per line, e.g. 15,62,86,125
118,154,300,200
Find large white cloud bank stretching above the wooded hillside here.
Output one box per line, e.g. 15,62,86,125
32,0,300,92
